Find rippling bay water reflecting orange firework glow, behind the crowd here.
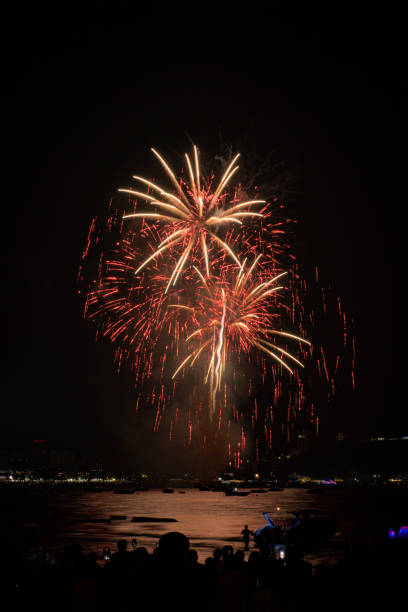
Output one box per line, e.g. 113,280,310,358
1,488,348,563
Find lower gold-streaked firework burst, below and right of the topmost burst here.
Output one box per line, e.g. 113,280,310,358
169,256,310,414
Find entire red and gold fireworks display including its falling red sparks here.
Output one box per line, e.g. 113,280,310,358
78,146,356,468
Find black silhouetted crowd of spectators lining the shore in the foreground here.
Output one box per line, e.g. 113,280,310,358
1,532,408,612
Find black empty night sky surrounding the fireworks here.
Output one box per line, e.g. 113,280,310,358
1,3,408,462
